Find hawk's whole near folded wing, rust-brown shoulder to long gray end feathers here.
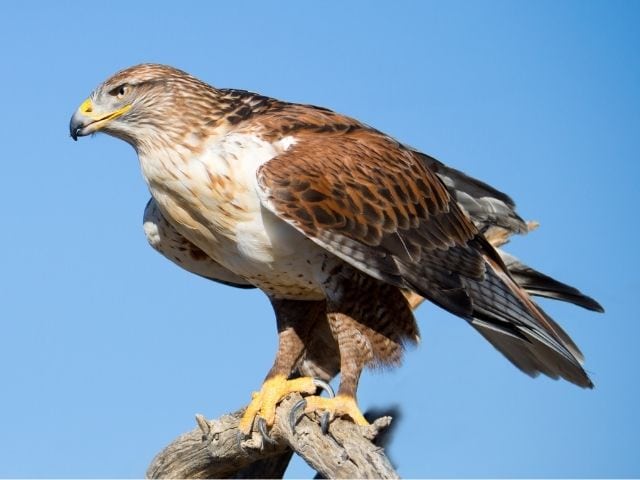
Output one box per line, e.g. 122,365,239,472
258,124,591,386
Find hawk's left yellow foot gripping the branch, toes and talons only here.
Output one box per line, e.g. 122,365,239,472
239,375,331,435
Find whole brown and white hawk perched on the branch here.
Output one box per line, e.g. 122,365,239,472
70,64,602,434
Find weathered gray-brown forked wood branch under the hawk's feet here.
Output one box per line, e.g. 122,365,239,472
146,394,398,478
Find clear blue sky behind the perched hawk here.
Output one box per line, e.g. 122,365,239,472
0,1,640,477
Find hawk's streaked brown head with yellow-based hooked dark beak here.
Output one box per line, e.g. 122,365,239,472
69,64,216,148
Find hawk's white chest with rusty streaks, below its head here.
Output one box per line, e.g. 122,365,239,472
140,133,308,276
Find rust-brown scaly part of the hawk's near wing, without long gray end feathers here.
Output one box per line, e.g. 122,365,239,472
258,129,484,315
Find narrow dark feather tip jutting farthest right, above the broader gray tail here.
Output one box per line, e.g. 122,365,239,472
497,249,604,312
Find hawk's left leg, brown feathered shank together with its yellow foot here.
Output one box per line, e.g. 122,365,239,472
239,299,327,435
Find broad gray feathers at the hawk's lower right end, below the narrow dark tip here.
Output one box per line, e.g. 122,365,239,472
464,261,593,388
